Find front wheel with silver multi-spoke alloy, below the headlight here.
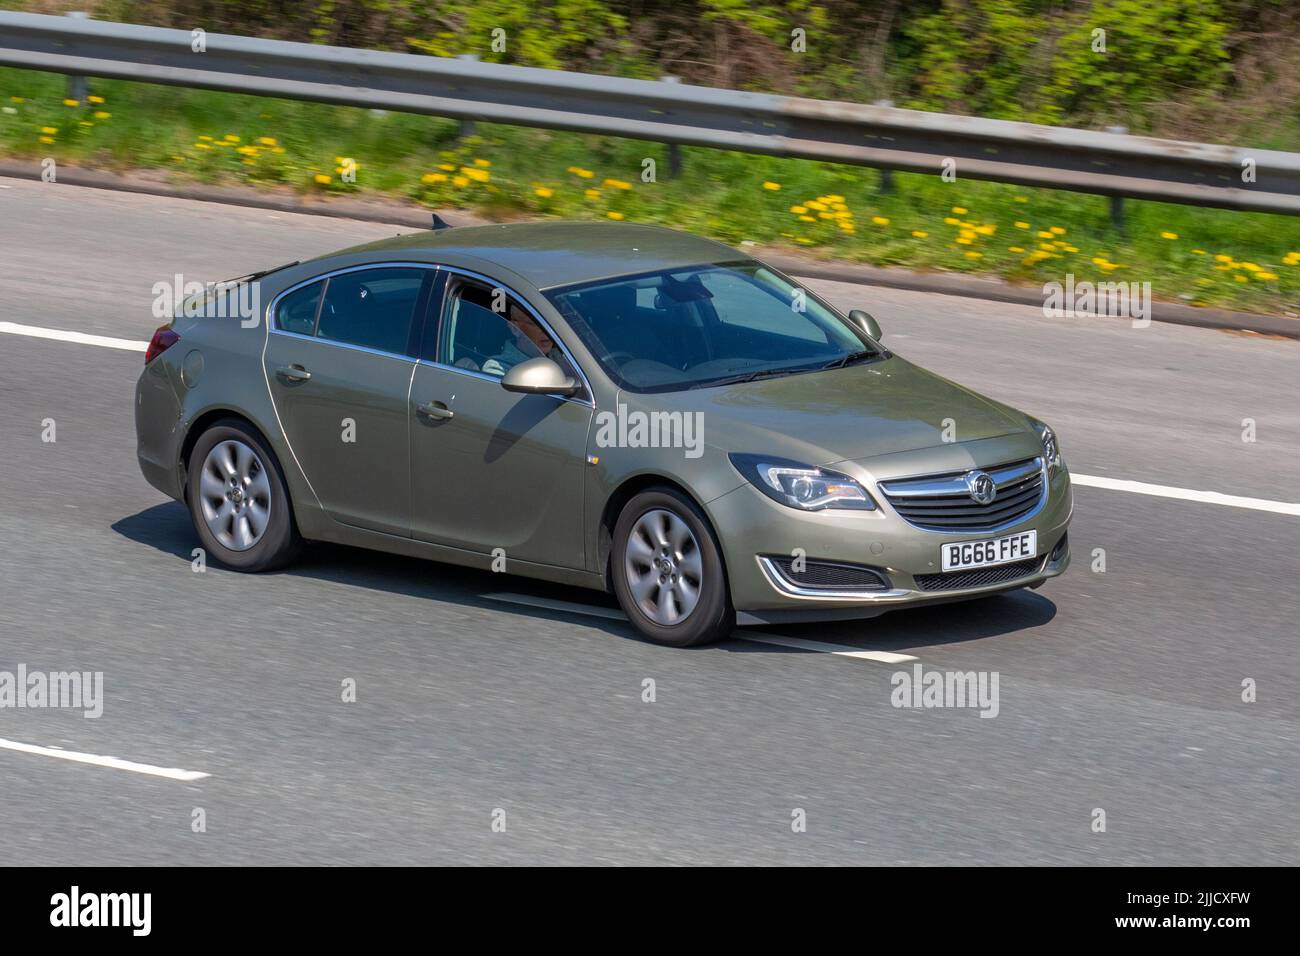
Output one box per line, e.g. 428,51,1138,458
612,488,736,648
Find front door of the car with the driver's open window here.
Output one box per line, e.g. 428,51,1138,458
411,272,593,570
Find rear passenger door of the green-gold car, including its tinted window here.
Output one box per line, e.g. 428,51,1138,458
264,265,436,537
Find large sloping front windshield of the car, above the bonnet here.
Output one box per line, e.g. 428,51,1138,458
547,261,880,392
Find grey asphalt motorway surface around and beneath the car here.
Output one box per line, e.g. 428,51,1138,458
0,179,1300,865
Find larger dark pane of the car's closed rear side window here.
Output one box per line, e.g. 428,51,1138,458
316,267,429,355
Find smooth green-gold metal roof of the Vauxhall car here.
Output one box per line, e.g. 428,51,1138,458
335,221,748,289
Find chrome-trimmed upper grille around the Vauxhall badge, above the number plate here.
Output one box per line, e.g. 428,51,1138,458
880,458,1047,532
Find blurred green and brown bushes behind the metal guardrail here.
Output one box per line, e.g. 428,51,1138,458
22,0,1300,144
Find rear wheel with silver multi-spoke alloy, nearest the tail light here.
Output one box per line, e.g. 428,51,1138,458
186,419,300,571
